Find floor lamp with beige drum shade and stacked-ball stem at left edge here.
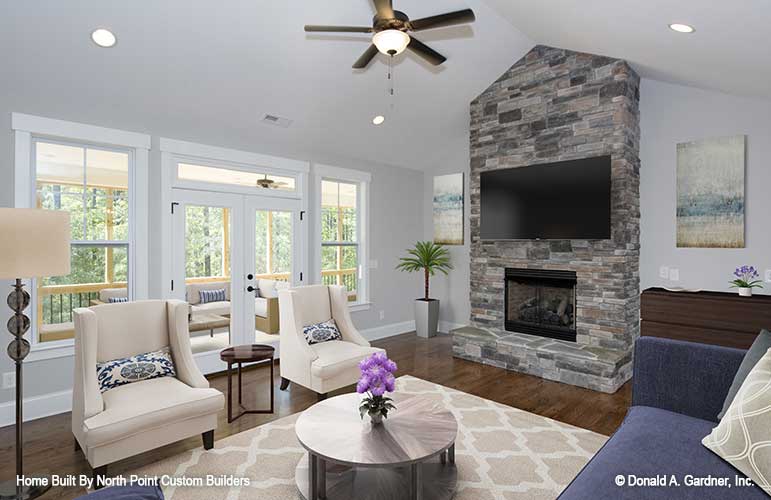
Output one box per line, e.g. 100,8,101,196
0,208,70,500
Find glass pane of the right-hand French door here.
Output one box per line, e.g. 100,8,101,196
254,210,293,343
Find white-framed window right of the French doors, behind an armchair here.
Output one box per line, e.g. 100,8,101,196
315,165,370,309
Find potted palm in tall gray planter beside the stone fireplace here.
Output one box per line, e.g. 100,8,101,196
396,241,452,338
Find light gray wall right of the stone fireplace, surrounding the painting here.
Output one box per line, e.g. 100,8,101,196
640,80,771,294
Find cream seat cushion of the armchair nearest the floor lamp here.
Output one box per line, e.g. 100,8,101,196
83,377,225,447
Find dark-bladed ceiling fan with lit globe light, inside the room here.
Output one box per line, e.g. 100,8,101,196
305,0,476,69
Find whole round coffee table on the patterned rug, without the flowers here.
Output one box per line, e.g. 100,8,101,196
295,394,458,500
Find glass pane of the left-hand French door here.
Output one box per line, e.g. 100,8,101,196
185,205,232,353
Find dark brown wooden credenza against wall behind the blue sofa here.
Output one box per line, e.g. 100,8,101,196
640,288,771,349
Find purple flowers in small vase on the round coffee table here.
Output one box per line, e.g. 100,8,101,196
356,352,396,424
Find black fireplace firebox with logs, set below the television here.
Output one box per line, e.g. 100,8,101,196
505,268,577,342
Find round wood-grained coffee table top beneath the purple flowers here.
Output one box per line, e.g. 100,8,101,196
295,393,458,467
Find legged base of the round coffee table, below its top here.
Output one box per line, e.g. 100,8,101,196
295,449,458,500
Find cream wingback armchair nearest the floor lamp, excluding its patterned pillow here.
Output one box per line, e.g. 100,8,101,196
72,300,225,476
